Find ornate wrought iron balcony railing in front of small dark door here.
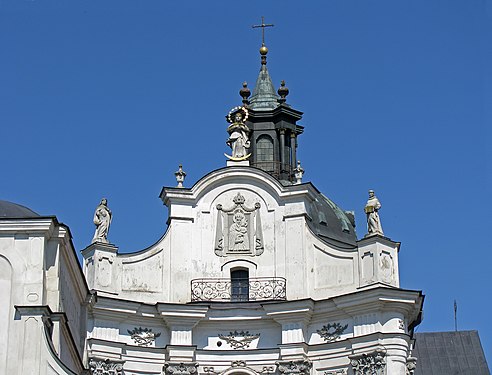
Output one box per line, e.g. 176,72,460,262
191,277,286,302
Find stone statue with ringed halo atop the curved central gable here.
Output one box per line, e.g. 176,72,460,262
226,107,250,160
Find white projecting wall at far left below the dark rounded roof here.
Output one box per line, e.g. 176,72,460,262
0,217,89,374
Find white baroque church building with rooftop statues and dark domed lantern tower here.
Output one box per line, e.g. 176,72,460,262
0,41,424,375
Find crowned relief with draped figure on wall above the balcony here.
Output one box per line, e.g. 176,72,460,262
215,193,264,256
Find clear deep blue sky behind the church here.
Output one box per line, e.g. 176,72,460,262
0,0,492,364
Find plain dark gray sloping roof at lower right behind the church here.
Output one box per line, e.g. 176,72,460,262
412,331,490,375
